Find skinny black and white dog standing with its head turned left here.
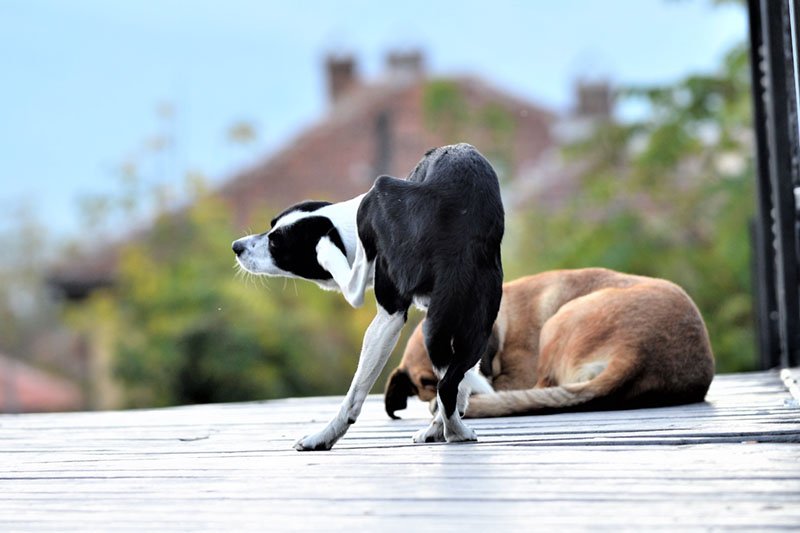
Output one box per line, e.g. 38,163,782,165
233,144,504,450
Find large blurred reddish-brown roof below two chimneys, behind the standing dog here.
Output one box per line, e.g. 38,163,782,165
219,77,554,228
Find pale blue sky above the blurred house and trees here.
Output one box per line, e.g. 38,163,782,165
0,0,747,239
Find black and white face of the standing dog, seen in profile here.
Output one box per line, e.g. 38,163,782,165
233,201,347,286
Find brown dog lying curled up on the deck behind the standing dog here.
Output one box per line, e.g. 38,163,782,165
385,268,714,418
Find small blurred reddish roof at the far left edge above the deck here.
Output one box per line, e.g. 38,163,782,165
0,354,84,413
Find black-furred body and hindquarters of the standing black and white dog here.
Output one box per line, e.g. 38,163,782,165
358,144,504,416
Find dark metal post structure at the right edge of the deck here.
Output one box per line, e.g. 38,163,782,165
749,0,800,367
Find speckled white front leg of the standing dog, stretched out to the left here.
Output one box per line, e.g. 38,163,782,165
294,305,405,451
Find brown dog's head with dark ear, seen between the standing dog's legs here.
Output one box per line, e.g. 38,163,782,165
384,323,439,418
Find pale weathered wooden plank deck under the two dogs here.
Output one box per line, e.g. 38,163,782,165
0,372,800,532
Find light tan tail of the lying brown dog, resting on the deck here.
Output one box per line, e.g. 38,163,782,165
467,381,599,418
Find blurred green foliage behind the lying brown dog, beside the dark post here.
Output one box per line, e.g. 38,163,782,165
505,47,755,372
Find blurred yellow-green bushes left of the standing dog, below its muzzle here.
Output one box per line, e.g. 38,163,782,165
68,191,390,406
